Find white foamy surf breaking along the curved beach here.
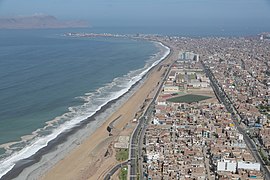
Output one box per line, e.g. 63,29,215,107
0,39,170,178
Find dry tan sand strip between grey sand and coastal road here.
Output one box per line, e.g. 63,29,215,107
40,40,177,180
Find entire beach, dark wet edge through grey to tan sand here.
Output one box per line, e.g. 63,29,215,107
2,36,178,180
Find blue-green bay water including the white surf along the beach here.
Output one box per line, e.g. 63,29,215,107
0,29,169,178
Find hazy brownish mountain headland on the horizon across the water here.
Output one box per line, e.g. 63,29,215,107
0,15,88,29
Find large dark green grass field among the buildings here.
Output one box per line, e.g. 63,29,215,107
167,94,211,103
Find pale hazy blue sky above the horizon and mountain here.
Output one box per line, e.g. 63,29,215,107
0,0,270,26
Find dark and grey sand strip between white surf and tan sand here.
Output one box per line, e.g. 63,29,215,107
1,37,173,179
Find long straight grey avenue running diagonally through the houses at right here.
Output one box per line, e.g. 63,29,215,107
201,61,270,180
